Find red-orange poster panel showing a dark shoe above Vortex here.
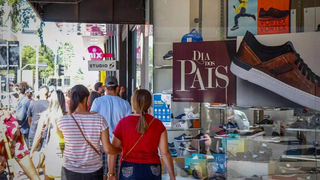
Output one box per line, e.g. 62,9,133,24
258,0,290,35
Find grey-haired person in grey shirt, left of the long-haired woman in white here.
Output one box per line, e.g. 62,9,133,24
28,86,49,148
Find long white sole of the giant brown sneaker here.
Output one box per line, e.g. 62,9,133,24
230,62,320,111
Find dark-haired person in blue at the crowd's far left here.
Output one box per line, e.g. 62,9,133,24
15,82,30,147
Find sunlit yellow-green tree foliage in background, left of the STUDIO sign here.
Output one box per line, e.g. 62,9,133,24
21,46,54,79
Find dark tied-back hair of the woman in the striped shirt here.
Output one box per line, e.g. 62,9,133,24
69,85,90,114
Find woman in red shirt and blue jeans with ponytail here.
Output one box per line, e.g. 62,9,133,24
109,89,175,180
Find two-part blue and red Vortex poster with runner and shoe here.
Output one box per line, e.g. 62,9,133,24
227,0,290,38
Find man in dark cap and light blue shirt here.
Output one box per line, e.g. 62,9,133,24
91,76,132,179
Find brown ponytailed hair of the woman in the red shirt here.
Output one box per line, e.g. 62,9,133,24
131,89,152,134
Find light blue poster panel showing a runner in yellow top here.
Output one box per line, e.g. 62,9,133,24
227,0,258,38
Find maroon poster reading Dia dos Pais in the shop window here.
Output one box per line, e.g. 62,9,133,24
173,41,236,103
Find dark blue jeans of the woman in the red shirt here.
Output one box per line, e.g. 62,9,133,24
119,161,162,180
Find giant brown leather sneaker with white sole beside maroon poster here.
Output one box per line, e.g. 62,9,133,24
231,32,320,111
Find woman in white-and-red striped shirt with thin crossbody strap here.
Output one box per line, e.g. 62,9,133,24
57,85,121,180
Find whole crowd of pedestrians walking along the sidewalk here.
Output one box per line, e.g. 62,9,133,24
0,76,175,180
